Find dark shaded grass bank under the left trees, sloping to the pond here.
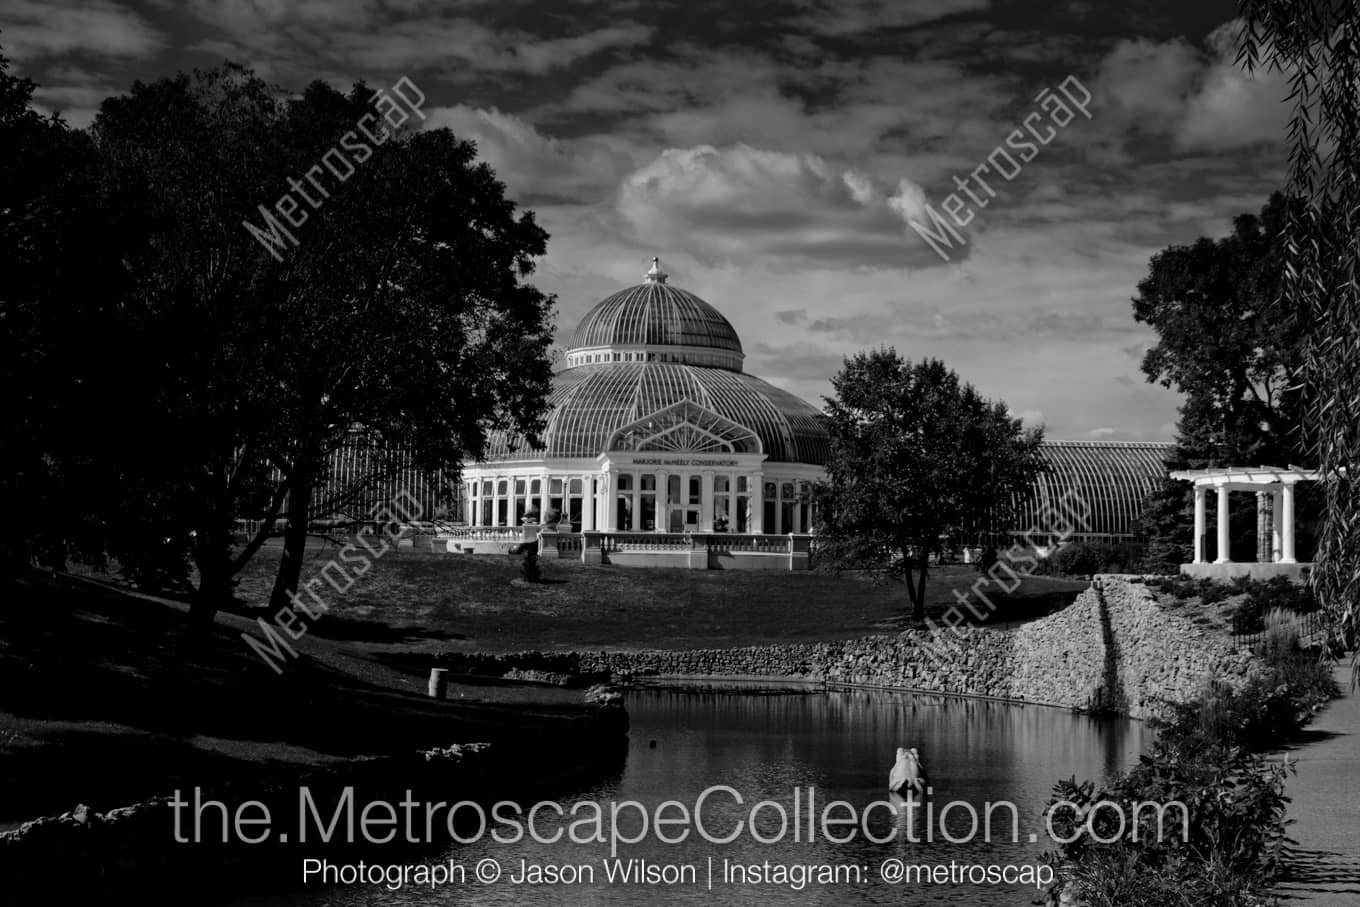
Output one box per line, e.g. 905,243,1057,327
0,582,622,819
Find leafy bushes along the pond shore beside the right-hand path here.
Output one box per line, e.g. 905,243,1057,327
1047,595,1338,907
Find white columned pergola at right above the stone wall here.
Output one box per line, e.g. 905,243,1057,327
1171,466,1318,564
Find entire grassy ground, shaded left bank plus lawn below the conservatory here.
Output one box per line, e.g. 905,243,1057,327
0,540,1085,828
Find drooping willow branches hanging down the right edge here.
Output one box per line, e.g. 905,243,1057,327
1238,0,1360,670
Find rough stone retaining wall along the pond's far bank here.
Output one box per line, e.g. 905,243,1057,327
450,577,1251,718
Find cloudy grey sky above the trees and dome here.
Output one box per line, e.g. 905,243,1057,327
0,0,1287,441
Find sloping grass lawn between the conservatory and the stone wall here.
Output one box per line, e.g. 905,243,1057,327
228,540,1085,651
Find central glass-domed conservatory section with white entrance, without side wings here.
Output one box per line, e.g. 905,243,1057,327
462,258,830,560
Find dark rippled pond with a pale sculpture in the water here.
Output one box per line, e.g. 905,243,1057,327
239,689,1151,907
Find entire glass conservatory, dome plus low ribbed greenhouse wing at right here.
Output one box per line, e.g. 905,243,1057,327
437,258,1171,570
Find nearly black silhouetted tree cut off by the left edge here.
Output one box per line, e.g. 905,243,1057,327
0,46,133,575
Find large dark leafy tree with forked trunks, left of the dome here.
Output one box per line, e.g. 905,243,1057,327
55,65,552,620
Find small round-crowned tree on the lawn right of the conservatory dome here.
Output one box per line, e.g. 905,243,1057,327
817,348,1043,620
